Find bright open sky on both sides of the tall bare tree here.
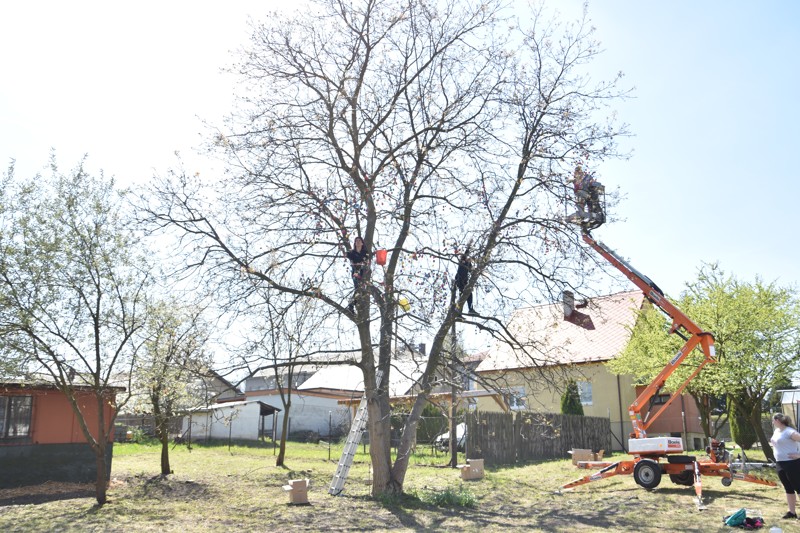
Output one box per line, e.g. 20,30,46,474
0,0,800,295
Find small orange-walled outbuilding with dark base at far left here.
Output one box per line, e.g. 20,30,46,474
0,382,125,488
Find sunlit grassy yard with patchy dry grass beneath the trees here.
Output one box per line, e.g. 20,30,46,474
0,443,800,533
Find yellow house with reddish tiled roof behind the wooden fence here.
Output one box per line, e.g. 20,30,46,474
476,291,703,450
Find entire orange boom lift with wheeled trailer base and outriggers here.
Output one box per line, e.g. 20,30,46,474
561,226,775,509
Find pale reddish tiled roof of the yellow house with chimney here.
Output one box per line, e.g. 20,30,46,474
476,291,644,372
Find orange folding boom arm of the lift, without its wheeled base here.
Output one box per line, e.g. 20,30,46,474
583,231,716,438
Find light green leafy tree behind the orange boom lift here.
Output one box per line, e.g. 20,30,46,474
609,264,800,460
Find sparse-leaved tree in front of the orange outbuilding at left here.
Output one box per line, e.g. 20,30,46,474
0,158,149,505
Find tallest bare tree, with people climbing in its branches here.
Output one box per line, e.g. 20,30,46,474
147,0,625,494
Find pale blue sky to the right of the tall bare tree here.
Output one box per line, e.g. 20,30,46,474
576,0,800,295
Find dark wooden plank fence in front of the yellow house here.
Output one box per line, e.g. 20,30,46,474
466,411,611,466
